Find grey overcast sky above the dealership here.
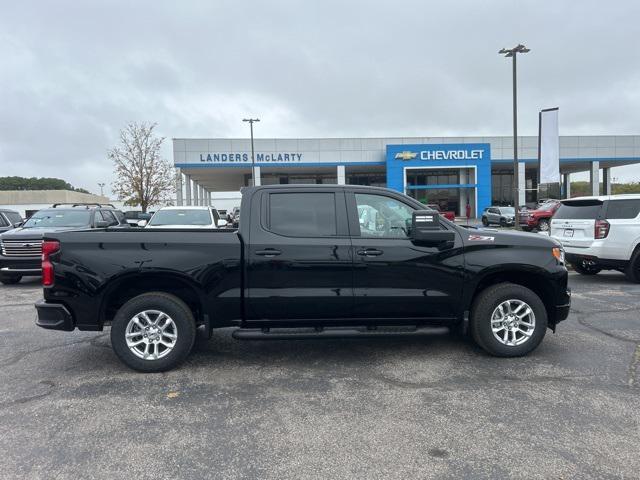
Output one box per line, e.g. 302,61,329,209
0,0,640,192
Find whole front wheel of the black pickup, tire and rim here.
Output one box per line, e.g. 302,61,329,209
470,283,547,357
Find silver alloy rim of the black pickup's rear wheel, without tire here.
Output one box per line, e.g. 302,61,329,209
125,310,178,360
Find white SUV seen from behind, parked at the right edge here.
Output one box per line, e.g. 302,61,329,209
551,195,640,282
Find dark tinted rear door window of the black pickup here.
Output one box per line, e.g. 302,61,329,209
269,193,336,237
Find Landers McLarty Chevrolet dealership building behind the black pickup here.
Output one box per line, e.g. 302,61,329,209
173,135,640,217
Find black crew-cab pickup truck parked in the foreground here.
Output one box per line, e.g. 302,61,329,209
36,185,570,372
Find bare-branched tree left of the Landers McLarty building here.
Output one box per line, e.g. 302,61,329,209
108,123,175,212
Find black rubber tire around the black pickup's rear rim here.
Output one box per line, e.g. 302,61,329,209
111,292,196,372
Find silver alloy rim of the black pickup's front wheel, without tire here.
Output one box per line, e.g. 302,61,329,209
491,299,536,347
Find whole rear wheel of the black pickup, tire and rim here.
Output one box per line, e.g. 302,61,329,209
111,292,196,372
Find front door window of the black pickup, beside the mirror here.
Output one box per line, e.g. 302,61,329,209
356,193,413,238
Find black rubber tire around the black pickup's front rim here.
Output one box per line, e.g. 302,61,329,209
469,283,547,357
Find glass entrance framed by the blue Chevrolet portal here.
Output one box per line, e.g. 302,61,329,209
405,167,477,218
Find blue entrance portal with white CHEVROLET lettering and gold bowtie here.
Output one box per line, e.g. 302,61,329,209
386,143,491,217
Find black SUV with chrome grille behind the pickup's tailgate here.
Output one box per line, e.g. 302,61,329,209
0,203,127,284
